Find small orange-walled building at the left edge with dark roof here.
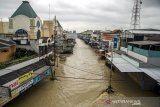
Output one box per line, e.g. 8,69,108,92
0,39,16,62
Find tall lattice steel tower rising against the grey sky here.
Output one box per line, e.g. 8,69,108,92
130,0,142,29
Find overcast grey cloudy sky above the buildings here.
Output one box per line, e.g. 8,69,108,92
0,0,160,32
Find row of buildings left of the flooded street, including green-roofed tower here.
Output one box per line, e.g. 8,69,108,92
0,1,76,106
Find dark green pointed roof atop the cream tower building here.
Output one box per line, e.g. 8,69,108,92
11,1,37,18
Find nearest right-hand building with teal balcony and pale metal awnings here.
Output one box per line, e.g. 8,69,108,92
106,41,160,91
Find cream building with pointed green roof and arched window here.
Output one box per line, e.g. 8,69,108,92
9,1,42,51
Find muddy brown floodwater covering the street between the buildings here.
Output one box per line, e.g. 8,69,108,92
6,39,156,107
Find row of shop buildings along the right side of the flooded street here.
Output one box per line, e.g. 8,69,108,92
78,29,160,93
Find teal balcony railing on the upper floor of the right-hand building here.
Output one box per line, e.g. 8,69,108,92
128,45,160,57
